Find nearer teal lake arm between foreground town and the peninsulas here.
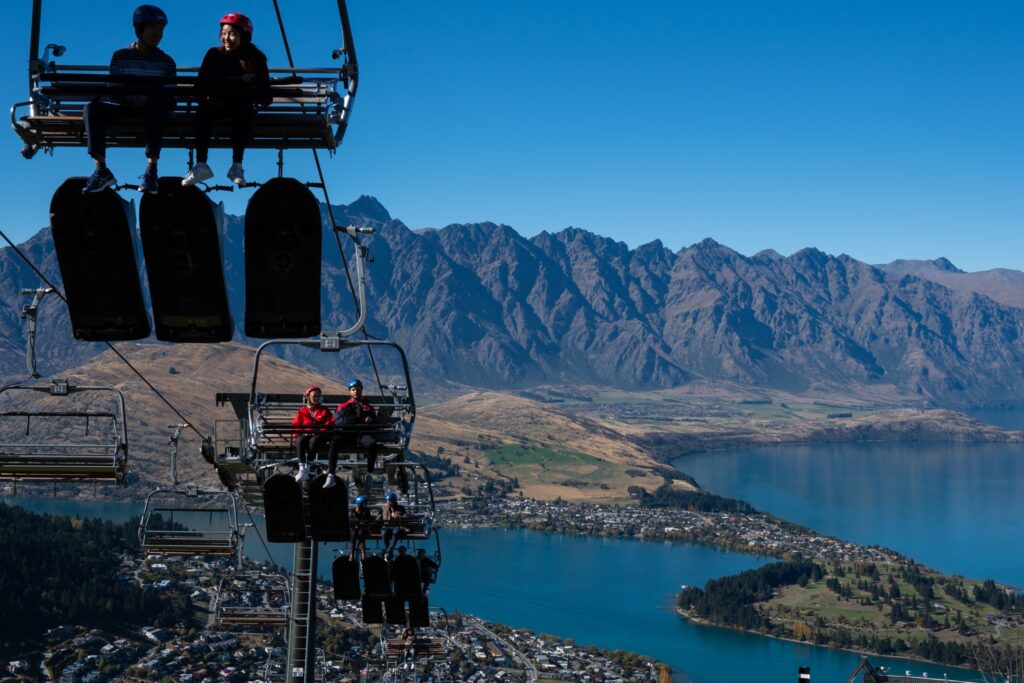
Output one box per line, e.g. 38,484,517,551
4,499,980,683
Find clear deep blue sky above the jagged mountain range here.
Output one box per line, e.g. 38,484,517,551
0,0,1024,270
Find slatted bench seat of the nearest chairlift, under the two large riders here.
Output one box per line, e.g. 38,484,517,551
11,65,347,157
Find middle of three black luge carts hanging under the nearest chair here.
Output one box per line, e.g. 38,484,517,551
139,176,233,343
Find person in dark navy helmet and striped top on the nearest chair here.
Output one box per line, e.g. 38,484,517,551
82,5,177,195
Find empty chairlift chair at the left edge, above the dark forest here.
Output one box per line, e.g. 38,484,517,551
0,380,128,484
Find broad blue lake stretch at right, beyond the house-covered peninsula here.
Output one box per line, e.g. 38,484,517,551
675,443,1024,587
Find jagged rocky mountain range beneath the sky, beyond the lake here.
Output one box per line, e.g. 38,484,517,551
0,192,1024,404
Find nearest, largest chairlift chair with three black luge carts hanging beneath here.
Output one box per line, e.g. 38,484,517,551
19,0,358,343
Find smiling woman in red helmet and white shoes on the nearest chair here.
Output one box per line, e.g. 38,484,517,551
181,12,273,187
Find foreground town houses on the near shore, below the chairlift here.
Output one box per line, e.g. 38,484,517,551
4,557,671,683
